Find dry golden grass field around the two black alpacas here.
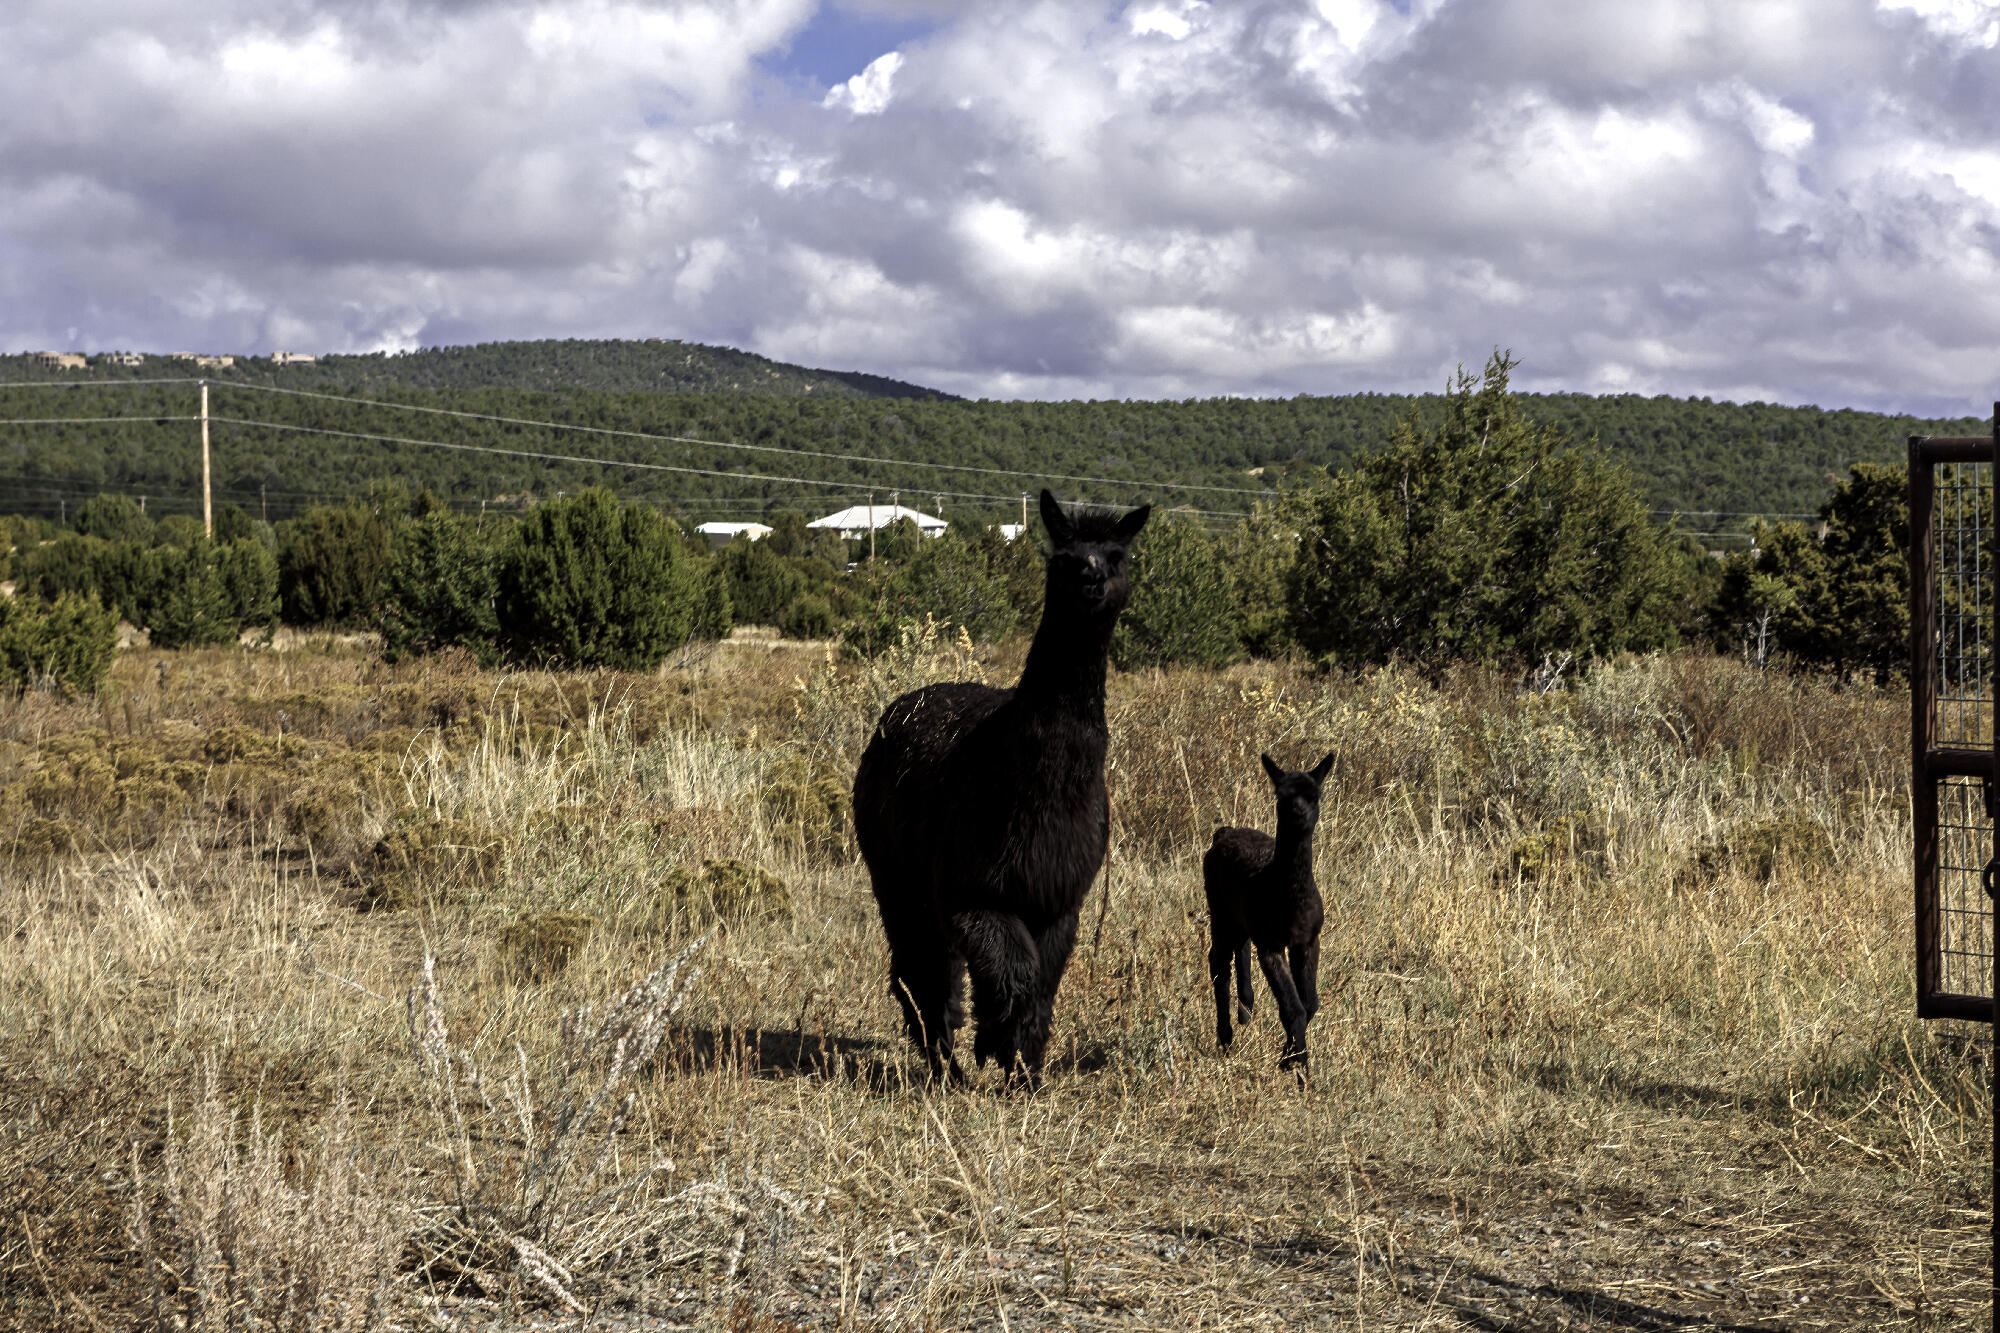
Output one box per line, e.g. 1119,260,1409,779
0,640,1992,1333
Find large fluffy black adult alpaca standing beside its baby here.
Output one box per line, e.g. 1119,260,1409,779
854,490,1152,1081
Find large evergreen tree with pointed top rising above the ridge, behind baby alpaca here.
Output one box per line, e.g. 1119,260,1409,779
1288,352,1680,667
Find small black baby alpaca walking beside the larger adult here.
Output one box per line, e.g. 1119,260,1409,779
1202,755,1334,1077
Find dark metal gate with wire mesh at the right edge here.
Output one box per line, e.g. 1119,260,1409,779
1910,416,2000,1023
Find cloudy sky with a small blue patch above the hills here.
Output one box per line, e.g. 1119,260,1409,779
0,0,2000,416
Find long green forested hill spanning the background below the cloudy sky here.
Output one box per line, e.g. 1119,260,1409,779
0,342,1990,532
